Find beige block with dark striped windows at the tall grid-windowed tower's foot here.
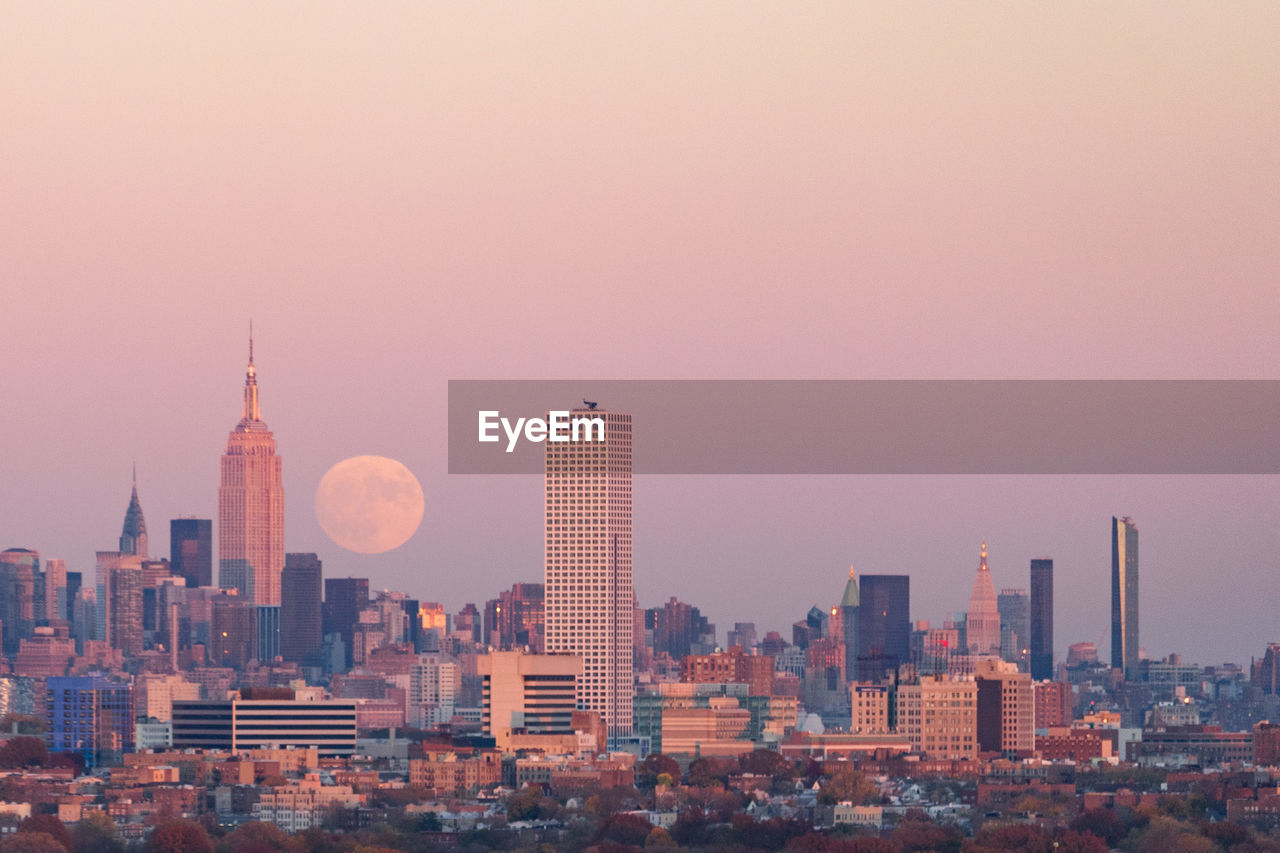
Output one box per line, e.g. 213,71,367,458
476,652,582,749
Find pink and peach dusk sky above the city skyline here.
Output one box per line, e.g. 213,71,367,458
0,0,1280,663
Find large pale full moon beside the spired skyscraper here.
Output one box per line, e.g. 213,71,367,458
316,456,424,553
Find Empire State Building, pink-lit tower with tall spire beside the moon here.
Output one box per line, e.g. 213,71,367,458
218,334,284,661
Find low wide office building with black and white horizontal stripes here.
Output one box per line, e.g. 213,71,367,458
173,688,356,758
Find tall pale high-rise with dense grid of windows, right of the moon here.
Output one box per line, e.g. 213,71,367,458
544,403,635,736
